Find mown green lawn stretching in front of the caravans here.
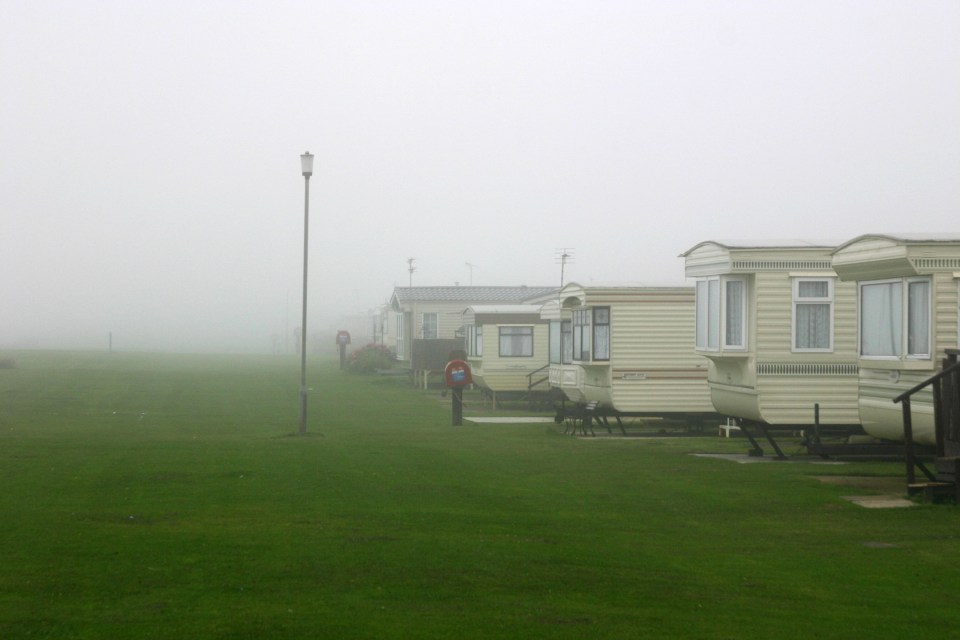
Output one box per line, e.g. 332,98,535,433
0,352,960,640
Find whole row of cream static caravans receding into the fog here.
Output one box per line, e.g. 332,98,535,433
377,235,960,444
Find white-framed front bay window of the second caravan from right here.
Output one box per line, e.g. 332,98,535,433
696,277,747,351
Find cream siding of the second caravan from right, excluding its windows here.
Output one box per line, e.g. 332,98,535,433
685,243,860,425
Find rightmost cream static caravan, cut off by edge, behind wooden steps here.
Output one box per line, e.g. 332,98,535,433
833,235,960,445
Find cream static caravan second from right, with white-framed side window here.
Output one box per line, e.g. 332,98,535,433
681,241,860,438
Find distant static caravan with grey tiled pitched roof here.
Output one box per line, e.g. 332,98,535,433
390,286,556,387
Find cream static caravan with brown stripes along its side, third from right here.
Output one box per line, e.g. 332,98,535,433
541,282,714,422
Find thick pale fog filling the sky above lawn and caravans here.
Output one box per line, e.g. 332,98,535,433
0,0,960,352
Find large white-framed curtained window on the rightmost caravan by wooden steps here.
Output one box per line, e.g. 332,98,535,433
860,278,930,359
